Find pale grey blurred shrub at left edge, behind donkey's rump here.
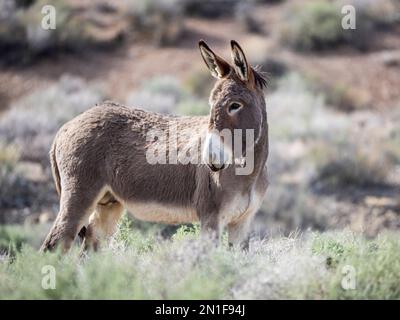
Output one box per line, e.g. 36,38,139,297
0,76,103,164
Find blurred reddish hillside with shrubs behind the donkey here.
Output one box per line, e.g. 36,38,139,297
0,0,400,249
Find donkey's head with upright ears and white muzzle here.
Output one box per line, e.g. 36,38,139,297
199,40,266,171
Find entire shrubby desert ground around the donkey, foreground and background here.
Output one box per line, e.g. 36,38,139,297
0,0,400,299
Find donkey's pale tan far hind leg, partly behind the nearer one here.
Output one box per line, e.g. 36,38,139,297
82,195,124,251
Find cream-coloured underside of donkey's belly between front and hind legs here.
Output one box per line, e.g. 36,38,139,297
125,201,198,224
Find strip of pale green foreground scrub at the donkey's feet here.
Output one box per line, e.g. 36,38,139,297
0,218,400,299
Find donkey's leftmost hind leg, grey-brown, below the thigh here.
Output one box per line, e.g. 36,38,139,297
40,189,101,252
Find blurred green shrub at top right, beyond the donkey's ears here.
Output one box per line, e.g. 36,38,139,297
280,0,390,51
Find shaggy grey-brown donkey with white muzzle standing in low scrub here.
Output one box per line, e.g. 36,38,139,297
41,40,268,251
